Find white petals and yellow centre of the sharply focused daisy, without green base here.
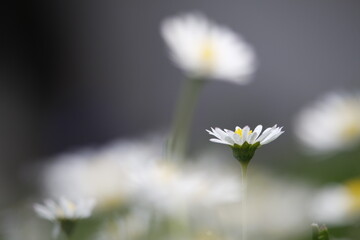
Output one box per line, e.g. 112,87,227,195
206,125,284,146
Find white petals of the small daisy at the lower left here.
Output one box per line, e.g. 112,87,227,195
34,198,95,221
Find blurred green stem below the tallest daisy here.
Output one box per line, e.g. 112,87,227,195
167,79,205,160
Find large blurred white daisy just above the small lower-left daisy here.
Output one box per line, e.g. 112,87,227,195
42,137,161,210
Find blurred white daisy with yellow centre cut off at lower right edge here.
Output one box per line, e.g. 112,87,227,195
310,179,360,225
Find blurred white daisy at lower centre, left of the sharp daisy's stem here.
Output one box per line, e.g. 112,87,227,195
131,162,240,215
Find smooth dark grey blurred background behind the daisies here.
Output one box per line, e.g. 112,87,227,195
0,0,360,202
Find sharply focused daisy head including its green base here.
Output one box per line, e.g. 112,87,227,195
206,125,284,164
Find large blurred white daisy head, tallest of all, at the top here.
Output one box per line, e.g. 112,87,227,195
161,13,255,83
